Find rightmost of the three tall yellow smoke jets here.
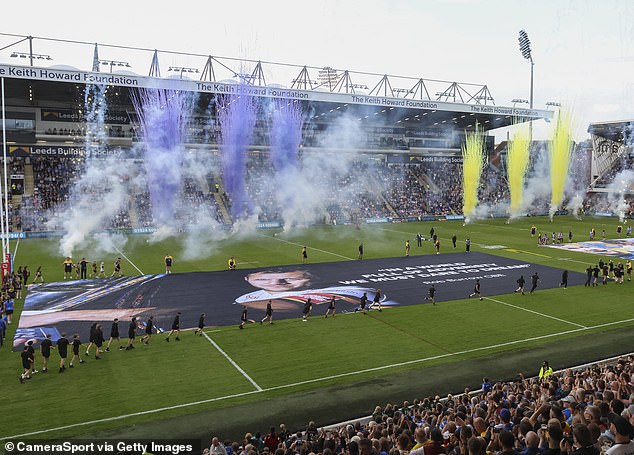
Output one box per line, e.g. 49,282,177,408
549,110,573,221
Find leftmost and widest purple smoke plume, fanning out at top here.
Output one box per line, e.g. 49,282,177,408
132,89,193,226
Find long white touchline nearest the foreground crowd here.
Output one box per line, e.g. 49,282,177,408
0,318,634,441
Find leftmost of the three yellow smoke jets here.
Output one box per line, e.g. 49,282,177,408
462,123,484,222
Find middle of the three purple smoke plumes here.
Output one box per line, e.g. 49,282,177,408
217,90,257,221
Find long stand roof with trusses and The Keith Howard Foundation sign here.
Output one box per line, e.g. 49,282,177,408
0,33,553,130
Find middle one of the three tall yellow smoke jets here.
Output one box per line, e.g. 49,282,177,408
506,121,531,218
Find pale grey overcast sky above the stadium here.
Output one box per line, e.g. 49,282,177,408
0,0,634,139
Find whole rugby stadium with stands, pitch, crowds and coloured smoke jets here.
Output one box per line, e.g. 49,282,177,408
0,22,634,455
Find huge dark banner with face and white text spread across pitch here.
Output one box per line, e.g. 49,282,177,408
14,251,585,349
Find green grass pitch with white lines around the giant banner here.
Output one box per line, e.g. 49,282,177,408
0,217,634,439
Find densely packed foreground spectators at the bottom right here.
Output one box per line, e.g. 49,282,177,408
205,356,634,455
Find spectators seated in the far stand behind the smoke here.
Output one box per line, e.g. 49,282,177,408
8,154,634,231
